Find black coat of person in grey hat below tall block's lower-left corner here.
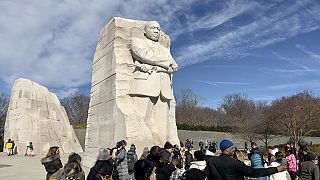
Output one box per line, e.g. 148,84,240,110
87,160,114,180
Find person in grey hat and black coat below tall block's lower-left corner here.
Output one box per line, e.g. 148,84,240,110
87,148,114,180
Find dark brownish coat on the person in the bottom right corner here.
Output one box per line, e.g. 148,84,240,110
299,161,319,180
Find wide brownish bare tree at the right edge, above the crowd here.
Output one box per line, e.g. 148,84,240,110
267,91,320,148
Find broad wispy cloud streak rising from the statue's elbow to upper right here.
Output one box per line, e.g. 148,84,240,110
176,0,320,66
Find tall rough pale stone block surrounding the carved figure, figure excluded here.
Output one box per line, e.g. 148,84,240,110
84,18,179,167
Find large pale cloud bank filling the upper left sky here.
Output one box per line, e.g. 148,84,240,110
0,0,196,89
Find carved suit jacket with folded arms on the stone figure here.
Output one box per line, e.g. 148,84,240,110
130,38,175,100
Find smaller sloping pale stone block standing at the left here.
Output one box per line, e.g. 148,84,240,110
4,78,83,155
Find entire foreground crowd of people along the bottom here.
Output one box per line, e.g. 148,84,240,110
41,139,319,180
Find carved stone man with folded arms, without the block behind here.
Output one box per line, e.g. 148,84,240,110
130,21,178,145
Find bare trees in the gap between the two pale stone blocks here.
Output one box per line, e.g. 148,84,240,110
61,93,90,124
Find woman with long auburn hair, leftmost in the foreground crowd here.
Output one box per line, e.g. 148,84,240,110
41,146,62,180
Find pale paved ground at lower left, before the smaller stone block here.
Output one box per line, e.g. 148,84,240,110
0,152,90,180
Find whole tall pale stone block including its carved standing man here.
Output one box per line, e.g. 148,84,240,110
84,18,179,166
